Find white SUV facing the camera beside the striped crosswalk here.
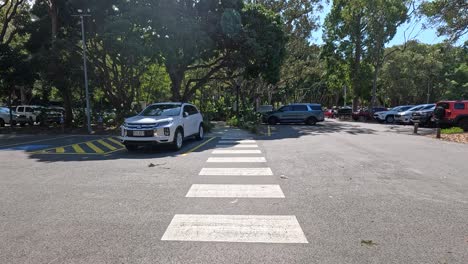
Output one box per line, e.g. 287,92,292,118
120,103,204,151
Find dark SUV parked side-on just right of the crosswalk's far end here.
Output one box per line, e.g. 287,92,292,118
263,104,325,125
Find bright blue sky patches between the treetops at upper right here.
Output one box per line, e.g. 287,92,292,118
311,4,454,47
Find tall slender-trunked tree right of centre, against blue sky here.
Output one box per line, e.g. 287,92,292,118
324,0,407,108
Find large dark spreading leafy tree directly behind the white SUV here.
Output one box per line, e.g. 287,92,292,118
143,0,286,101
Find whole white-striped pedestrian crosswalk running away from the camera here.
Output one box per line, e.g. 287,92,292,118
161,136,308,244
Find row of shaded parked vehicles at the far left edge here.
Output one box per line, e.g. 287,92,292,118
0,105,64,126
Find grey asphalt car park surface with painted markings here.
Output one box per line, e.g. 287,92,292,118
0,121,468,264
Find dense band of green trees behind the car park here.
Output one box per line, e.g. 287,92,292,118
0,0,468,125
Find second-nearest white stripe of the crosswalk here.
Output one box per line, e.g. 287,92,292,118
185,184,284,198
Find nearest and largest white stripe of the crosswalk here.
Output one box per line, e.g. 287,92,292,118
161,214,308,243
